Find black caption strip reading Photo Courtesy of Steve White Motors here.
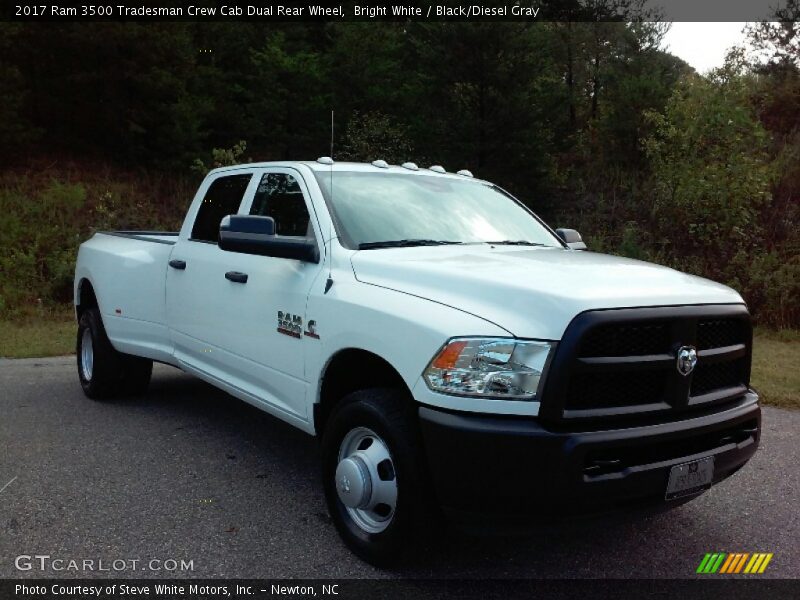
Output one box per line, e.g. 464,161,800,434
0,576,800,600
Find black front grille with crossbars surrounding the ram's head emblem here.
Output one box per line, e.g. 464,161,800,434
540,305,752,420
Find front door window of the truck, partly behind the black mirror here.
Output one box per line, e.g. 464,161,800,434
250,173,314,237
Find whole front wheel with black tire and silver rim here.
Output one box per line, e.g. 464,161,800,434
322,389,429,565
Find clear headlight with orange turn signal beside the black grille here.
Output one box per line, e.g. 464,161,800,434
424,338,553,400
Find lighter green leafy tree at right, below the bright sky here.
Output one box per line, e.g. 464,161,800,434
644,69,773,280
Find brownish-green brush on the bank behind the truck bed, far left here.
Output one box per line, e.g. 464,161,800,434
0,169,193,318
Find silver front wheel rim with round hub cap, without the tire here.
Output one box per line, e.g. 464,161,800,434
335,427,397,533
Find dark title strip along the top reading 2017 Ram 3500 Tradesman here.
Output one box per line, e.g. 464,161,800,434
0,0,787,24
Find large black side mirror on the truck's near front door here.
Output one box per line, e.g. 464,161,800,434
219,215,319,263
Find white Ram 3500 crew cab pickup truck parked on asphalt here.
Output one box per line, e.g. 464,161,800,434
74,157,761,563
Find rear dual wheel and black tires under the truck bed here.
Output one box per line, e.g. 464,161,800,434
75,308,153,400
